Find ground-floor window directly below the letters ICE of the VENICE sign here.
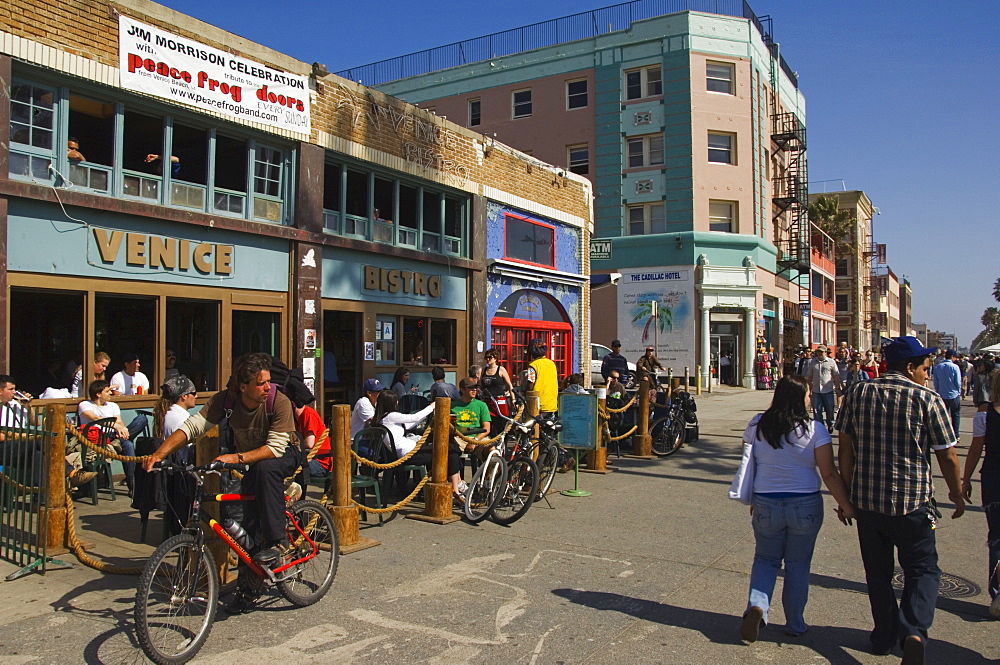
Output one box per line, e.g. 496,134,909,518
164,299,220,390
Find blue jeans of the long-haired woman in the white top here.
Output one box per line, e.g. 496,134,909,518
747,492,823,635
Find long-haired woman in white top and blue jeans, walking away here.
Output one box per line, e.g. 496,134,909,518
740,376,854,642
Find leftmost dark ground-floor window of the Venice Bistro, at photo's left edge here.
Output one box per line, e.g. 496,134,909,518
8,289,83,395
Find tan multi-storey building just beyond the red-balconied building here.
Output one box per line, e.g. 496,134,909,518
809,190,885,350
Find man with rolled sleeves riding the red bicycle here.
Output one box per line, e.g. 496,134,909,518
143,353,299,613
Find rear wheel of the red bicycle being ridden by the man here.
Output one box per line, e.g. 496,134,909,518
278,499,340,607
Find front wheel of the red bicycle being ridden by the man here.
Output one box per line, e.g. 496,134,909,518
135,533,219,665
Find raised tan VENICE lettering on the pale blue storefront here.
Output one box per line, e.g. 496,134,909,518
93,227,234,277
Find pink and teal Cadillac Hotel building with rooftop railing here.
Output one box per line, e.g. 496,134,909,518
348,0,811,387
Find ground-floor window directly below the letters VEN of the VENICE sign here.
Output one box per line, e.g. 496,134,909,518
94,293,156,380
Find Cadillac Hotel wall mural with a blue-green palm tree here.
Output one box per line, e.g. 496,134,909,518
618,266,698,375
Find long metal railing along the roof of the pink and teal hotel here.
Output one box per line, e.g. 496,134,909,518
336,0,798,87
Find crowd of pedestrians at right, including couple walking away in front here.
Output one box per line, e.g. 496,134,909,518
730,336,1000,665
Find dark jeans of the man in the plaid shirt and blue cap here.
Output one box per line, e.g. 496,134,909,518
856,506,941,651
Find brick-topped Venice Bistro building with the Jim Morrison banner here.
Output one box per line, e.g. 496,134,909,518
0,0,592,408
